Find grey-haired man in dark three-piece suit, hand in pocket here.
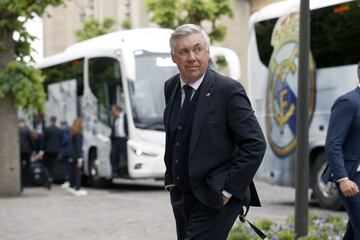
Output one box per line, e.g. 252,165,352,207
164,24,266,240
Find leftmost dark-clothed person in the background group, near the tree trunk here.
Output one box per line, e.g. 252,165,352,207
19,118,34,187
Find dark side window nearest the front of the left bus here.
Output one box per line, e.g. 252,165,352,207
89,57,122,124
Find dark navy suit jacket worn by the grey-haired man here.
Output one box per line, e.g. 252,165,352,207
164,70,266,208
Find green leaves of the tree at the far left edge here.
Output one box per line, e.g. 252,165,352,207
0,0,63,110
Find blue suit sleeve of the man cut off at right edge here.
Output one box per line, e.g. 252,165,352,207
325,98,354,181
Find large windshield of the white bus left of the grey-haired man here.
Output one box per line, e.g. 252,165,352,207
129,50,178,131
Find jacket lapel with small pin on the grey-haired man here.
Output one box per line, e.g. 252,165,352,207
189,70,214,159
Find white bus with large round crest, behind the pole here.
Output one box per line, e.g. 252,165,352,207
248,0,360,209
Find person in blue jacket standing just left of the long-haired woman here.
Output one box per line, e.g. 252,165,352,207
60,120,71,188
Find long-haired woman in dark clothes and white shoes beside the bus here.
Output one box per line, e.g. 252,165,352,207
69,118,87,196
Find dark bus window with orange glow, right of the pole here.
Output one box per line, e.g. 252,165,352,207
311,1,360,68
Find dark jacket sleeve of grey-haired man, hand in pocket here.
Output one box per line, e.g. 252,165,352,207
224,82,266,198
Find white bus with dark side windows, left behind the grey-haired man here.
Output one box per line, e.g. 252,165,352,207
38,29,240,185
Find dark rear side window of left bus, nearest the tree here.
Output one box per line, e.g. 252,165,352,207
41,59,84,97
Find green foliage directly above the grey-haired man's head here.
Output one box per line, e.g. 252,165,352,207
146,0,234,41
